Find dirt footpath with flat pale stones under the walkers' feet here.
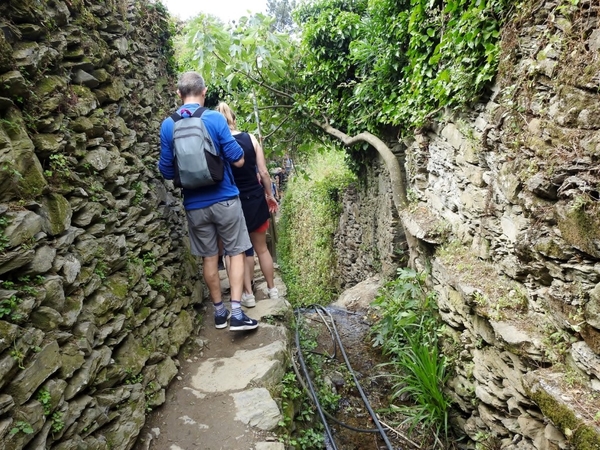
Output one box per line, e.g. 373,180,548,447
134,264,291,450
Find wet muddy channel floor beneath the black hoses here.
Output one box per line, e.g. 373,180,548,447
301,308,431,450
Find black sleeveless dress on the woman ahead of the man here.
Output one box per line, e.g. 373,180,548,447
231,133,271,233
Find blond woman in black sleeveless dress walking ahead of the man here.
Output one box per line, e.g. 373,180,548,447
217,102,279,307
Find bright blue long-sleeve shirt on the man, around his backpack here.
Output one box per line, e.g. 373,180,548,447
158,103,244,210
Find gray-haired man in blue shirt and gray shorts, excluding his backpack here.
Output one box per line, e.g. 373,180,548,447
158,72,258,331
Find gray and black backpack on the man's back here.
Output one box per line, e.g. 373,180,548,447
171,107,224,189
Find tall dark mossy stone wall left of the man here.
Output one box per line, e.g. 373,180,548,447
0,0,202,450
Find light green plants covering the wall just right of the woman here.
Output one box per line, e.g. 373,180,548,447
278,149,353,306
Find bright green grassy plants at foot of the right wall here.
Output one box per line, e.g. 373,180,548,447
372,269,452,448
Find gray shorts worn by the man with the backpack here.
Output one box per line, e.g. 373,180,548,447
186,197,252,256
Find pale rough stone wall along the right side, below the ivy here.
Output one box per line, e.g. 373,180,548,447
338,0,600,450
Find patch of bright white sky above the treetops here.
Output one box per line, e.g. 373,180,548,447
162,0,267,23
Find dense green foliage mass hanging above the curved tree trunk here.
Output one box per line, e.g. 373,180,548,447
297,0,515,134
